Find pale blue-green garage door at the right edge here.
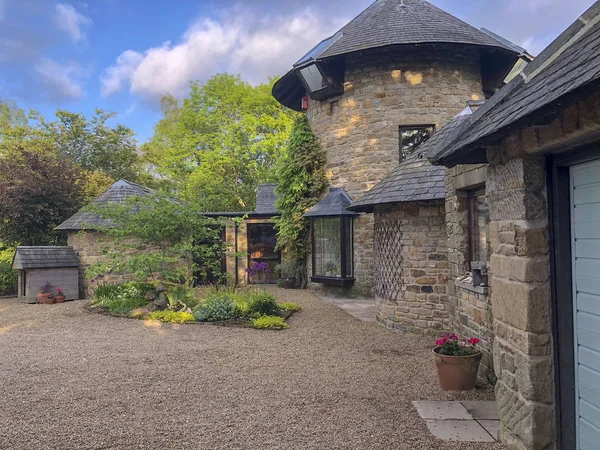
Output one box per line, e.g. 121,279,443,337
571,161,600,450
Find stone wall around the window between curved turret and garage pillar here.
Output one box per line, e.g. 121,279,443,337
446,164,496,383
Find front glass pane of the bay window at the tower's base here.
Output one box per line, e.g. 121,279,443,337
313,217,342,277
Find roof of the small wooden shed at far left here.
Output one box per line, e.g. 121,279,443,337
12,246,79,269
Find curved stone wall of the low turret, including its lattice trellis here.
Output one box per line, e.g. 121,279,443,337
374,200,450,336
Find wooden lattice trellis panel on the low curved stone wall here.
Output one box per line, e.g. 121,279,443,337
373,222,402,300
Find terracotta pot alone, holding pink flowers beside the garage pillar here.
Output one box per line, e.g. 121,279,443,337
433,347,481,391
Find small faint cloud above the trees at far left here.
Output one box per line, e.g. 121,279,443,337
34,58,86,101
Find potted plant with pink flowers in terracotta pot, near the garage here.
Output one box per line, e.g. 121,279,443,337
433,333,481,391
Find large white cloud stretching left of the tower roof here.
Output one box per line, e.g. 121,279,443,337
100,7,345,101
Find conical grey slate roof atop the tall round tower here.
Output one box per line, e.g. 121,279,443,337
318,0,515,58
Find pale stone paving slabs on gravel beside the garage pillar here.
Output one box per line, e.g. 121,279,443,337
413,401,500,442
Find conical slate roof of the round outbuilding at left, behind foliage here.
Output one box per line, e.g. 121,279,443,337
55,180,153,231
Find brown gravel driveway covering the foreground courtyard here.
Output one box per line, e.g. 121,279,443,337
0,290,503,450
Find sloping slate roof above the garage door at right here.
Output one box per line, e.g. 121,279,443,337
431,2,600,166
